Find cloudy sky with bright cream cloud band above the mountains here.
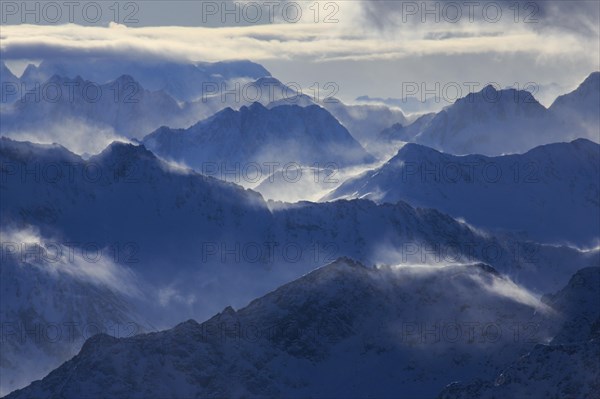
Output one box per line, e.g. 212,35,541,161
0,0,600,105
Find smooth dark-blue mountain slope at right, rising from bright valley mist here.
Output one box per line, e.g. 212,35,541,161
325,139,600,247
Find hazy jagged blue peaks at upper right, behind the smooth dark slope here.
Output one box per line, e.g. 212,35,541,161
390,72,600,156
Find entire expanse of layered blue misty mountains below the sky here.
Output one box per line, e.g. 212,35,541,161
0,57,600,399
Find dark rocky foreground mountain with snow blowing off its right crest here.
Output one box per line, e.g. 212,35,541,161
3,259,553,399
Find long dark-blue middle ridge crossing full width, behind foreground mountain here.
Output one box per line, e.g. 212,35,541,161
0,138,597,300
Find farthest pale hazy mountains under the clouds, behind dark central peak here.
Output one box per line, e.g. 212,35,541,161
2,61,600,163
